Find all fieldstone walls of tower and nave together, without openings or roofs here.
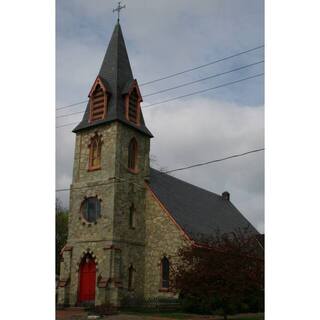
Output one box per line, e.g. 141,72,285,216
58,122,186,306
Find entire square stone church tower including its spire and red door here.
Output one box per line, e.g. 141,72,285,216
58,21,152,306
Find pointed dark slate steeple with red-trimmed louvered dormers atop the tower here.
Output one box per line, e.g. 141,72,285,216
73,21,152,137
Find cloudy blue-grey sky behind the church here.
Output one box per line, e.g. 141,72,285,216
56,0,264,232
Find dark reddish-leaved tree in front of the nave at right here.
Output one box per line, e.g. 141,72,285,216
171,230,264,319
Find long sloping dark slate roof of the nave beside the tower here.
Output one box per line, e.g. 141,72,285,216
149,168,259,241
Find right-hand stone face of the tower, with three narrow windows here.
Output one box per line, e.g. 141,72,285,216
114,123,150,300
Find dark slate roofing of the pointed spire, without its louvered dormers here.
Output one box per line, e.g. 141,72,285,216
73,23,152,137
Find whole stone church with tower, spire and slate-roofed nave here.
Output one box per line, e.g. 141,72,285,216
58,22,258,306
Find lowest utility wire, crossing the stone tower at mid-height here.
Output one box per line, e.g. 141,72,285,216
56,148,264,192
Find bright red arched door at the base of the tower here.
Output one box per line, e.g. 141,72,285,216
79,257,96,302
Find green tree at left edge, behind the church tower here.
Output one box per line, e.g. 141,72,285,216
56,199,68,274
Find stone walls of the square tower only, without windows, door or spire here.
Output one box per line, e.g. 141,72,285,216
58,122,150,305
